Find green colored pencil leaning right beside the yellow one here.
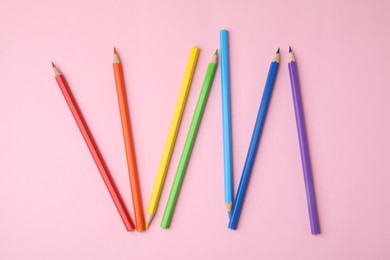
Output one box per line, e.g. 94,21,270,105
161,50,218,228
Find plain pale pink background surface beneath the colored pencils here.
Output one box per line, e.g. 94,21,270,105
0,0,390,260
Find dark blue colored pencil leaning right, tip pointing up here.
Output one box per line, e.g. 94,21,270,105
228,49,280,229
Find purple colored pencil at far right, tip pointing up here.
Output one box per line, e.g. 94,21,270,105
288,47,320,235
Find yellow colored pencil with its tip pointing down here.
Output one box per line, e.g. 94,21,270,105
146,47,199,228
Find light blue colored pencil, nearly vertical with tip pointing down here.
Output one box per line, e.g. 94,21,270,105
220,30,233,217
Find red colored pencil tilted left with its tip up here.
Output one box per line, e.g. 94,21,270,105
52,63,134,231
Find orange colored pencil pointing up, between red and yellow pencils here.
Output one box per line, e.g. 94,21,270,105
112,48,145,231
